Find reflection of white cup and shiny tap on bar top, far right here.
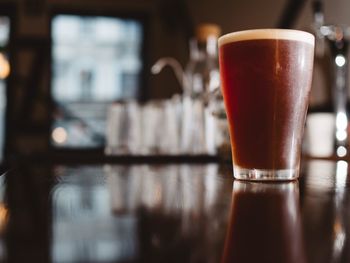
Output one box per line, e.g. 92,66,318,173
302,160,350,263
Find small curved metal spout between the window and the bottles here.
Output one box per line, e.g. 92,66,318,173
151,57,188,92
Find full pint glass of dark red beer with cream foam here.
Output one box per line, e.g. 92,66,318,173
219,29,315,180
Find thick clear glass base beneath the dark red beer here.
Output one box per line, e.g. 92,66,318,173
233,166,299,181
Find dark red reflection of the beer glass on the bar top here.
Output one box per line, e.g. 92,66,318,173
222,181,305,263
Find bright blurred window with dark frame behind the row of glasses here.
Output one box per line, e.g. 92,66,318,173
51,15,143,148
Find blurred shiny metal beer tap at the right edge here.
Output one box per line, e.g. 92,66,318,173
313,1,350,157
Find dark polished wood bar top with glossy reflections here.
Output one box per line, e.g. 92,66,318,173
0,160,350,263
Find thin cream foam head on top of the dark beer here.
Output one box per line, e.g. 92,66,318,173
219,29,315,46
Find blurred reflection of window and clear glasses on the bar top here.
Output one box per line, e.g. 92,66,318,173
51,165,232,263
